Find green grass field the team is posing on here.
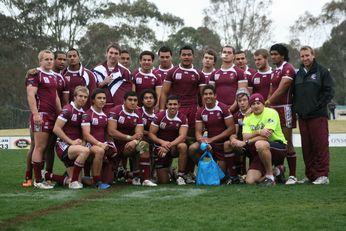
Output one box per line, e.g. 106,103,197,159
0,148,346,231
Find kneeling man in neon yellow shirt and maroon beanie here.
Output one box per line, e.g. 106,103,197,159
232,93,287,186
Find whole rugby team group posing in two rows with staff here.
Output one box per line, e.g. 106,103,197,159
22,44,334,189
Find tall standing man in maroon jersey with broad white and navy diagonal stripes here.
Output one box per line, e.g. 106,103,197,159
93,44,134,113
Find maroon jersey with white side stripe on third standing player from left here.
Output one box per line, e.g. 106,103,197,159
63,64,96,109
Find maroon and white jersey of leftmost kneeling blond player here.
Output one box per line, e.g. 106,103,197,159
58,102,84,140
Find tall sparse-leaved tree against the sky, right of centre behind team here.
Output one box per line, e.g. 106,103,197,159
204,0,272,50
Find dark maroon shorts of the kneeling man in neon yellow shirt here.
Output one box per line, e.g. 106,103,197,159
248,142,287,175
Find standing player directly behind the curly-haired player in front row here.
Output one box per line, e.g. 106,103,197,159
133,51,162,105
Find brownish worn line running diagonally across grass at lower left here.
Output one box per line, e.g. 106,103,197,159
0,185,129,230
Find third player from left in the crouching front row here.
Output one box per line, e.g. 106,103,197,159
108,91,157,186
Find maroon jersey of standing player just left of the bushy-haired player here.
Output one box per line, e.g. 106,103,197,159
248,68,272,100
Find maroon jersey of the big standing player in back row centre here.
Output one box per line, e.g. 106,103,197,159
165,65,206,107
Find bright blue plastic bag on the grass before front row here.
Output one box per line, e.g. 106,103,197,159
196,151,225,185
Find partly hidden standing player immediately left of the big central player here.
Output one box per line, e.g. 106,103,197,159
154,46,174,83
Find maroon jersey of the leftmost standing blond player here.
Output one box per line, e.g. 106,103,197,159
25,68,57,116
